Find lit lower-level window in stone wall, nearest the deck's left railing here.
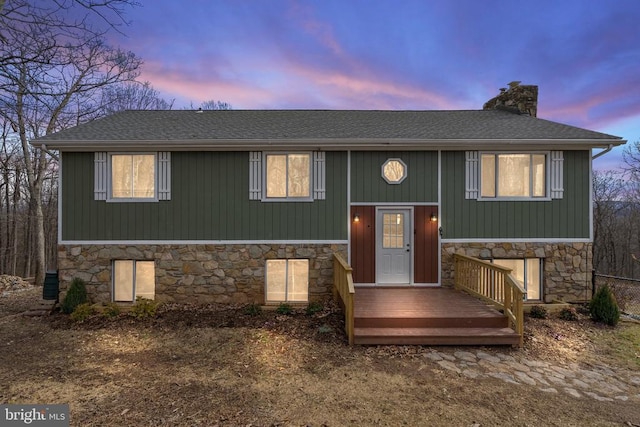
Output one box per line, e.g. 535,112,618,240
266,259,309,302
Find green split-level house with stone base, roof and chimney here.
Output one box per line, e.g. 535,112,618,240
33,83,625,316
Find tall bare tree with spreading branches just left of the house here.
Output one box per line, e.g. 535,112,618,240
0,0,141,283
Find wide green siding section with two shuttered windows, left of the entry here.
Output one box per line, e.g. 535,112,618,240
62,152,347,241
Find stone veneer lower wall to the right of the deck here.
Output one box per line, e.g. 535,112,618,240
442,242,593,302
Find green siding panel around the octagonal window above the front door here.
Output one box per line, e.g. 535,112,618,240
351,151,438,203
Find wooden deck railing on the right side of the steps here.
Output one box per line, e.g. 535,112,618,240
454,254,525,347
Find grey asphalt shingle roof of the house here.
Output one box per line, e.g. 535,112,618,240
35,110,624,148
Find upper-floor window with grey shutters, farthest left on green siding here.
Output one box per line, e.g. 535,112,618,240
94,152,171,202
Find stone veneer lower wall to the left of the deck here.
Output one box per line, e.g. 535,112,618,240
58,244,347,304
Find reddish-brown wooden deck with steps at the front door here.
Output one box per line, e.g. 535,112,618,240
354,287,520,345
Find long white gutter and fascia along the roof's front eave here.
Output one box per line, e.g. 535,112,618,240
42,138,626,151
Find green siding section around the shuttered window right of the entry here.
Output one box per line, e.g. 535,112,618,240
440,151,591,239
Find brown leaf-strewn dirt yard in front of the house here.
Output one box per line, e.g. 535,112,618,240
0,288,640,427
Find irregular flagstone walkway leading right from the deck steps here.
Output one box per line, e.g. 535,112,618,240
424,350,640,402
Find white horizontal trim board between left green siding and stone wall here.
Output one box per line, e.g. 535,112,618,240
59,240,348,245
